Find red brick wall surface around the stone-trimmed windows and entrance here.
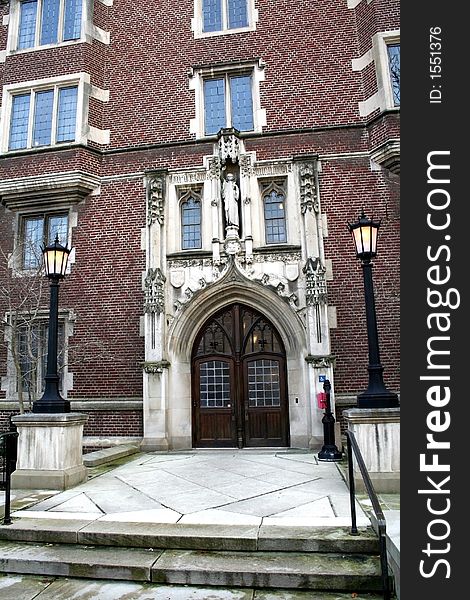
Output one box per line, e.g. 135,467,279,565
0,0,399,426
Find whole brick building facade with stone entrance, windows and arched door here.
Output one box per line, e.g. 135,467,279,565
0,0,400,449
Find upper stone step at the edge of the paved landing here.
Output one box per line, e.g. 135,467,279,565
0,518,379,554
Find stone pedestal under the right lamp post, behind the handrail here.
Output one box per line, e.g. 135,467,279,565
343,408,400,494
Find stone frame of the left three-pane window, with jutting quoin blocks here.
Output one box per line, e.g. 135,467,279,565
0,72,110,155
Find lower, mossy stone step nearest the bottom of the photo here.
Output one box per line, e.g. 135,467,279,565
0,541,381,592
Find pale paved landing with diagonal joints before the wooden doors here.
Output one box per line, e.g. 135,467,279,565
5,449,370,526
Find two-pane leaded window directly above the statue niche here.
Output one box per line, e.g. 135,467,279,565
204,75,254,135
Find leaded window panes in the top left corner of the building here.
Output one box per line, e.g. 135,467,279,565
17,0,83,50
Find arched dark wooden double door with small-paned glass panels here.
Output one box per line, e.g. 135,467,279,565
191,304,289,448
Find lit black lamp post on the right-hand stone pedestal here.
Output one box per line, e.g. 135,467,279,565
348,211,399,408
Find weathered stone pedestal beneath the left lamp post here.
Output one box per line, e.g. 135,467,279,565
11,413,88,490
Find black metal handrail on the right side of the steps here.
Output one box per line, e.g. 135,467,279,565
346,430,391,600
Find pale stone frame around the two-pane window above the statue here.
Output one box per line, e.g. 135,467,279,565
188,59,266,139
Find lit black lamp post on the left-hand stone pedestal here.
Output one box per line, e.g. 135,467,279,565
33,236,70,413
